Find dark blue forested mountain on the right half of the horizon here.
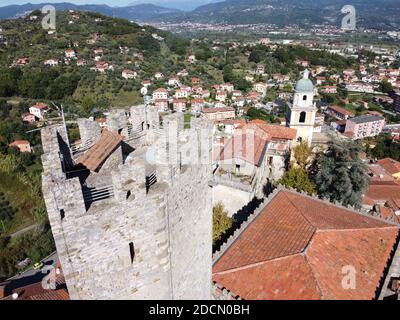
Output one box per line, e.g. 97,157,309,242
179,0,400,29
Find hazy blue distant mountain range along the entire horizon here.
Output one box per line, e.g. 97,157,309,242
0,0,400,30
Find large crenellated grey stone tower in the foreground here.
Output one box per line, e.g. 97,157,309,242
42,108,212,300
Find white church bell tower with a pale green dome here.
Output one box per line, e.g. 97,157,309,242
287,69,317,145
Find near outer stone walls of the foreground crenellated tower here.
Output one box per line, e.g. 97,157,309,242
42,112,212,299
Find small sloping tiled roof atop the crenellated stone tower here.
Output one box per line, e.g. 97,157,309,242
78,130,123,171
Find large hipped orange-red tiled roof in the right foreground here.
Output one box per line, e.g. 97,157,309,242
213,190,399,299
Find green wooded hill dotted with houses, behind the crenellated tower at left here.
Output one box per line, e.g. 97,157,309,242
0,12,189,109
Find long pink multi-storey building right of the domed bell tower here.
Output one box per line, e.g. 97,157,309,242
345,115,385,140
